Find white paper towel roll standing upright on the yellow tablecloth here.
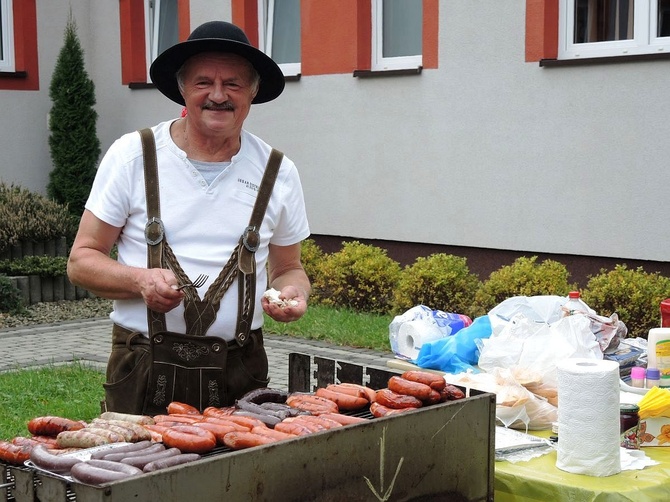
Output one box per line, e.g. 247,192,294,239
556,358,621,477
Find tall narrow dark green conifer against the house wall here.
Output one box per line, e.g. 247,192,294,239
47,11,100,216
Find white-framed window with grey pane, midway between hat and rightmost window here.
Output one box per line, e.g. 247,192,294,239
372,0,423,70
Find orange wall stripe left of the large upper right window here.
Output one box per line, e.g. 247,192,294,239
526,0,558,62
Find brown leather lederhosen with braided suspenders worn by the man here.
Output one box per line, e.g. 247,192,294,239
104,129,283,415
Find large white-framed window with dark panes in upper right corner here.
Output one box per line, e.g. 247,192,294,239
558,0,670,59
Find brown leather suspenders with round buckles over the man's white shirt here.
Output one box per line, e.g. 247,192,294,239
139,128,284,346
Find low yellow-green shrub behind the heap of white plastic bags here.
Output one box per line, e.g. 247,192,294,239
476,256,576,312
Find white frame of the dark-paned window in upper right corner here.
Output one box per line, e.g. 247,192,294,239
558,0,670,60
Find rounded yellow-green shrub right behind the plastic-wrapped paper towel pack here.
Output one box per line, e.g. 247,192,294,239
393,253,481,316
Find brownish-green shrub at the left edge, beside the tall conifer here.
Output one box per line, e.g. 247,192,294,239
0,182,78,251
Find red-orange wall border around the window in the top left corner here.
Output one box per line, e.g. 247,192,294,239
0,0,40,91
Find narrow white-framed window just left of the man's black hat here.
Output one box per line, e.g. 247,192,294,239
144,0,179,75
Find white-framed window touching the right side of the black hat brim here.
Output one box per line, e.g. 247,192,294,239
258,0,301,76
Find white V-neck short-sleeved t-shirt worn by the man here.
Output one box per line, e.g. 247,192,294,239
86,121,309,340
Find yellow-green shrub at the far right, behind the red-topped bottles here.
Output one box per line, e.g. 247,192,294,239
582,265,670,338
